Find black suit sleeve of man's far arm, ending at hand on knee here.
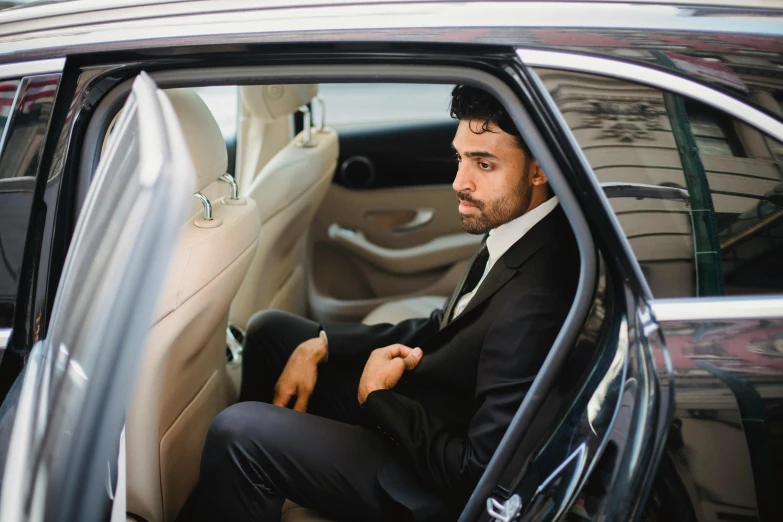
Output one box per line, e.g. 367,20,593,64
322,309,443,361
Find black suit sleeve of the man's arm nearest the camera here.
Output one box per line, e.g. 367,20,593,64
362,292,570,496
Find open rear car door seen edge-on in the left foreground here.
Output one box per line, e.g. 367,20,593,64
0,73,195,521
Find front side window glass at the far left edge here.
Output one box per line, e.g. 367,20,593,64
0,74,60,328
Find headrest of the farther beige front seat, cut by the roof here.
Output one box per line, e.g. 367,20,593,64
239,84,318,122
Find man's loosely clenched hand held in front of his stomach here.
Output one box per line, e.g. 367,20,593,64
359,344,422,404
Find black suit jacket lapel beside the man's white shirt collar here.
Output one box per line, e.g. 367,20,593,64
441,205,566,331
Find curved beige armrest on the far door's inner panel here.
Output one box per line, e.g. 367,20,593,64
329,223,481,274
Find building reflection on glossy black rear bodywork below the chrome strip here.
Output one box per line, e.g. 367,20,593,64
662,319,783,521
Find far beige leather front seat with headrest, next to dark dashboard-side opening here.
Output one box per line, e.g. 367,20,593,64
230,85,339,328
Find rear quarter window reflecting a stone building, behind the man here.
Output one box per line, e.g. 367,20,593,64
537,69,783,298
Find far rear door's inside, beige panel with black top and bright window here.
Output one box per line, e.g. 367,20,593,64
309,83,481,320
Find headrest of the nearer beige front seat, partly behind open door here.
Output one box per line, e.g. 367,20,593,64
164,89,228,192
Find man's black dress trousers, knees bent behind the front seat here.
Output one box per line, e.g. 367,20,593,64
178,311,415,522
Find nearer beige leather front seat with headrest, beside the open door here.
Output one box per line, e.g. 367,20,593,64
126,89,260,522
